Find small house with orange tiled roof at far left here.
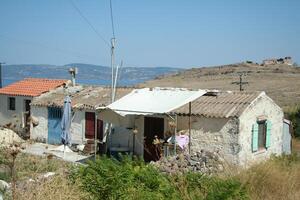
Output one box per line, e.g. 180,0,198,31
0,78,67,134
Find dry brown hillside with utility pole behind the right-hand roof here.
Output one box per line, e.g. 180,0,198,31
140,63,300,108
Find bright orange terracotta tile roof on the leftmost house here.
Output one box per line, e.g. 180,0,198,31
0,78,67,97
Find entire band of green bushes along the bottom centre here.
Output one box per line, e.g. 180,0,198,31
71,157,247,200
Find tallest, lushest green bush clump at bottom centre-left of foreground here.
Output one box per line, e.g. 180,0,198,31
72,157,179,199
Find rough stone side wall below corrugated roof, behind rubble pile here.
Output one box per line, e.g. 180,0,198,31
168,116,240,163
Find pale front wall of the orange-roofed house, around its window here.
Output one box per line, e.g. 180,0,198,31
0,94,32,130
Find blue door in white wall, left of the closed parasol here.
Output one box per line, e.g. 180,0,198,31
48,107,62,144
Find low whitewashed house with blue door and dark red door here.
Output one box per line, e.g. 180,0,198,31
30,85,131,144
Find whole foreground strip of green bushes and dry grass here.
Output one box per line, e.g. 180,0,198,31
0,140,300,200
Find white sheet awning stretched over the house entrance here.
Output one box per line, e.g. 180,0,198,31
103,87,206,116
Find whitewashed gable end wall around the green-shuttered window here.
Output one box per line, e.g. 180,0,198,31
238,94,283,166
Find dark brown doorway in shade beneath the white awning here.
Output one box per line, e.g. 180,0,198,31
144,117,164,162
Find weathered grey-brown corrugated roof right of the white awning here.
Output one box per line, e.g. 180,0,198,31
171,91,262,118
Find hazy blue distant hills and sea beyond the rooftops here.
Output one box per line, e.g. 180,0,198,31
3,63,180,86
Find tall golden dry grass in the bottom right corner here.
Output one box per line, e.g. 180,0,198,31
237,155,300,200
